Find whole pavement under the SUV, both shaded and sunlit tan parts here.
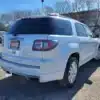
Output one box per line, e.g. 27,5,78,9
0,60,100,100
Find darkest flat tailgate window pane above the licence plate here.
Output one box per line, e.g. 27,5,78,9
10,18,53,34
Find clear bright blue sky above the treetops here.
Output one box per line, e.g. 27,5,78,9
0,0,71,13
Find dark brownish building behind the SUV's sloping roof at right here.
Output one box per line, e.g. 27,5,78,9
62,9,100,35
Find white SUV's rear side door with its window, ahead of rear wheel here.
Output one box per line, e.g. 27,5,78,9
75,22,94,64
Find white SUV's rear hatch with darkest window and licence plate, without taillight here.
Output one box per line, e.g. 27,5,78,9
3,17,53,62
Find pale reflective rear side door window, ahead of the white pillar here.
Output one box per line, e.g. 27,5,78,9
75,23,88,37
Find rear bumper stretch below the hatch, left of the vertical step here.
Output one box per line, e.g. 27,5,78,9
0,58,40,78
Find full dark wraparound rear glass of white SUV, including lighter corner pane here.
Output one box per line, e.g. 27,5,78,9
9,18,72,35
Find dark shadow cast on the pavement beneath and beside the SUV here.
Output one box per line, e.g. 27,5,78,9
0,61,100,100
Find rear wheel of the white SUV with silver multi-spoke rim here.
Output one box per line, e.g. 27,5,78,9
59,57,79,88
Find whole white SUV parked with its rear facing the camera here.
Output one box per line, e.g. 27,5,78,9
0,16,98,86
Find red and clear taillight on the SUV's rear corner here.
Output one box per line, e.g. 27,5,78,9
32,40,58,51
